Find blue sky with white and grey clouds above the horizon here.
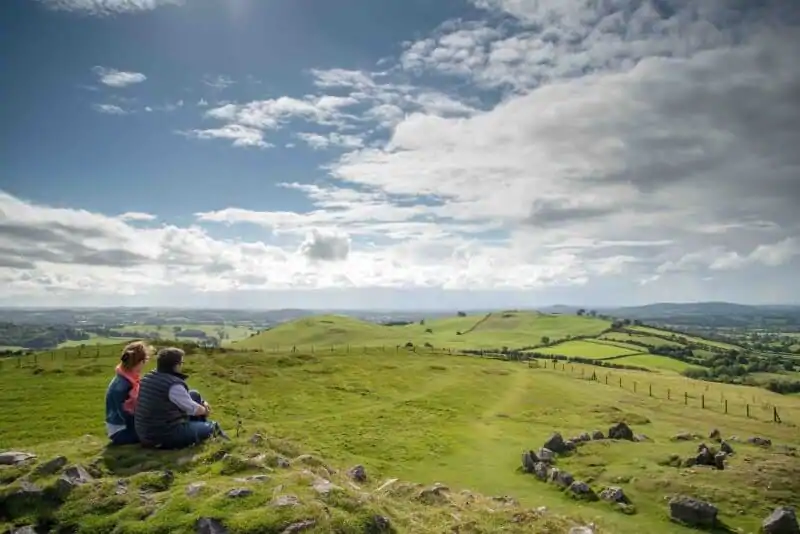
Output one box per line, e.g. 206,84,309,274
0,0,800,308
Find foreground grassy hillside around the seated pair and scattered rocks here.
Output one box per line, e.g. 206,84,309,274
0,347,800,534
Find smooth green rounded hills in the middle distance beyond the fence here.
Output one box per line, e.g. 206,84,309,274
233,312,610,350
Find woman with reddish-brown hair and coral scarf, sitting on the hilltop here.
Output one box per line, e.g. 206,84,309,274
106,341,153,445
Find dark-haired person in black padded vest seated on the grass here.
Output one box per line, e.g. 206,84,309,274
134,347,228,449
